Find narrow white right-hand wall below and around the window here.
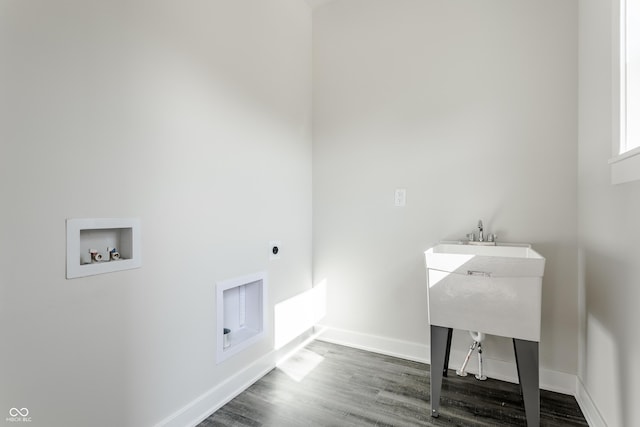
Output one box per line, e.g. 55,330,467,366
578,0,640,427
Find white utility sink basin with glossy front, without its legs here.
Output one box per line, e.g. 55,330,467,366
425,243,545,342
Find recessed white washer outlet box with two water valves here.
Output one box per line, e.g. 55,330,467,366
67,218,142,279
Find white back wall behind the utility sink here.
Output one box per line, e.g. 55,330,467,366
313,0,578,375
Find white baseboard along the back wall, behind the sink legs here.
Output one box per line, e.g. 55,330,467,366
318,327,576,396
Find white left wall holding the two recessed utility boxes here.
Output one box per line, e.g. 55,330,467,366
0,0,311,426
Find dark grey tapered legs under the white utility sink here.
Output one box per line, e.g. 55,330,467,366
430,325,540,426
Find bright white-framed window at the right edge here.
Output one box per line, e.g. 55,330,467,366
609,0,640,184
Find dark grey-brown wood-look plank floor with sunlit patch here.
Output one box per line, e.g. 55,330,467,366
199,341,588,427
